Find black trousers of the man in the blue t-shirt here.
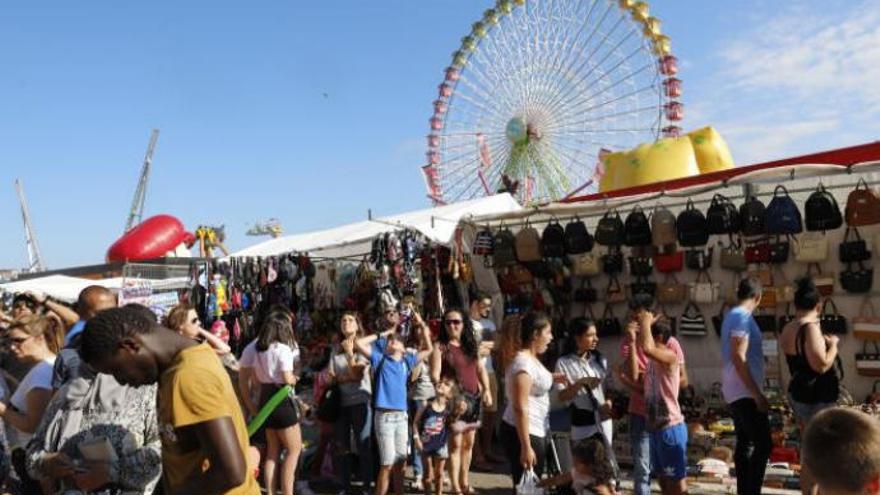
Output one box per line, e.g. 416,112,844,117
730,399,771,495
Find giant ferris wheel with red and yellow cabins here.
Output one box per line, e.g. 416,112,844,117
422,0,683,204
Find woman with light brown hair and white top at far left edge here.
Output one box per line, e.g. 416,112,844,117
0,315,64,450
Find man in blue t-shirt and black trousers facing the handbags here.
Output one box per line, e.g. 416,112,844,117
721,279,771,495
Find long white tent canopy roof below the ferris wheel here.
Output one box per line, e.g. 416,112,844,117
231,193,522,258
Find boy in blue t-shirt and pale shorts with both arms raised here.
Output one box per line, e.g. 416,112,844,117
357,308,433,495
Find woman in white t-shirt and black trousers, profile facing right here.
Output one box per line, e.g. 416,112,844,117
499,312,553,487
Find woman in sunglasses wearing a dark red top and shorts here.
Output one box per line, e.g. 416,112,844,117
431,309,492,494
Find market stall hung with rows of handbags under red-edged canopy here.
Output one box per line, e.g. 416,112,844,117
458,144,880,487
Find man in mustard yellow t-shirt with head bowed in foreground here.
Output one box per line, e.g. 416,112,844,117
80,308,260,495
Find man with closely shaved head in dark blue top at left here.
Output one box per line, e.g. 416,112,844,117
52,285,116,390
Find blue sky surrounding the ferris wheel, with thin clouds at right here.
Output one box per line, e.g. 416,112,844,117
0,0,880,268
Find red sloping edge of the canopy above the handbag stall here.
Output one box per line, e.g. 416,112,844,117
560,141,880,203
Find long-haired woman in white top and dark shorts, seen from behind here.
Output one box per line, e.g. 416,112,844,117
249,314,302,495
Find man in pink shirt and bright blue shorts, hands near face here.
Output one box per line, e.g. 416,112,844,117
624,309,687,495
